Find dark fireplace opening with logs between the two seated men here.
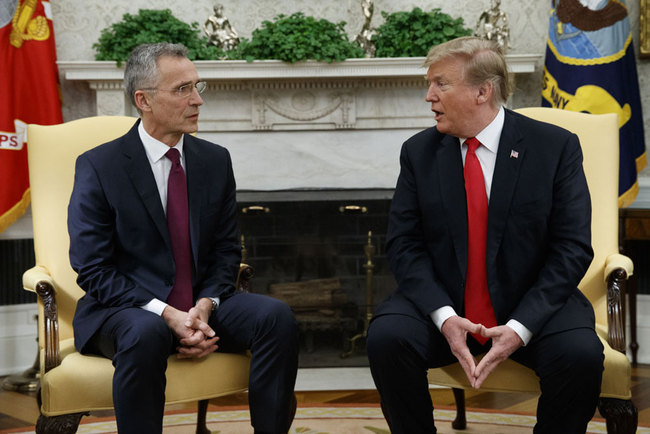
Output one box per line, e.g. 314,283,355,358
238,190,395,368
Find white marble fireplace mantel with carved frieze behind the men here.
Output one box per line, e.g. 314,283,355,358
58,55,542,192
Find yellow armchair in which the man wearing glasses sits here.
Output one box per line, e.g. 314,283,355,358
23,116,252,433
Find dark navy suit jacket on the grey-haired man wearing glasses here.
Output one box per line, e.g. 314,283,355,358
68,121,241,351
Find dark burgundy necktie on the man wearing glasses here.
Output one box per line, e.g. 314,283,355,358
165,148,194,312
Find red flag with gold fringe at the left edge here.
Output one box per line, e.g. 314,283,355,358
0,0,63,232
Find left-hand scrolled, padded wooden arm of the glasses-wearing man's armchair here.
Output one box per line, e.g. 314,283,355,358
23,266,61,372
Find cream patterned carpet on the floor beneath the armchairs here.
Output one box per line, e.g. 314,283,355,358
0,405,650,434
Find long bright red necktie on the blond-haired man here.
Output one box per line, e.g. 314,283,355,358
464,137,497,344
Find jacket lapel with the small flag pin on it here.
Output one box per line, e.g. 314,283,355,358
486,110,526,268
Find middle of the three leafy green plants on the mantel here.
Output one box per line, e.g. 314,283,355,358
232,12,364,63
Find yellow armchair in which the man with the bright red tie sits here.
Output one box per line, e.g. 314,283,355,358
428,107,638,434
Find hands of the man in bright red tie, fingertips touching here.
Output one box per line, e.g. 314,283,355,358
441,316,524,389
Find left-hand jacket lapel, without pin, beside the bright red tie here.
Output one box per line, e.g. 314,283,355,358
437,136,467,276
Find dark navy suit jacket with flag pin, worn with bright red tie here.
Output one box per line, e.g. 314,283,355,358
376,110,594,337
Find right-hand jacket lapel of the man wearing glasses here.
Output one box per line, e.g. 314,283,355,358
183,135,204,270
